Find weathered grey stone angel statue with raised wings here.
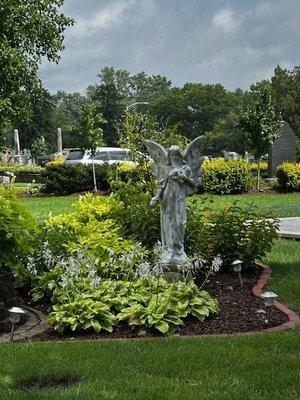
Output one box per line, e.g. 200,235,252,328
145,136,204,273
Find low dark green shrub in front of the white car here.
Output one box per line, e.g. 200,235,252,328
42,163,109,194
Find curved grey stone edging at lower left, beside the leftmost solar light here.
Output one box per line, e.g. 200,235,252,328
0,306,49,343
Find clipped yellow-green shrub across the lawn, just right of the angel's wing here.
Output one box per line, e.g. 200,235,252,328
202,158,253,194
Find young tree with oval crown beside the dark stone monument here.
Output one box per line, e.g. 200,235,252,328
239,82,282,189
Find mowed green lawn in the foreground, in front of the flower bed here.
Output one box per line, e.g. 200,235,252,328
0,330,300,400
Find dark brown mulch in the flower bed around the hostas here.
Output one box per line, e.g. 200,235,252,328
28,268,287,341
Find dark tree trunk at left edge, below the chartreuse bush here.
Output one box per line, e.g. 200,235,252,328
0,267,17,320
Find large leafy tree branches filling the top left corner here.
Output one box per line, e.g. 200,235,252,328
0,0,74,125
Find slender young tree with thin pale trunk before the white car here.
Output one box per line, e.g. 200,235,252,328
79,103,106,192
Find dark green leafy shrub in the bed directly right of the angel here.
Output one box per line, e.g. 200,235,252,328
186,202,277,267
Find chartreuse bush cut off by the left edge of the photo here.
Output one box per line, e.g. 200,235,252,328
0,185,37,274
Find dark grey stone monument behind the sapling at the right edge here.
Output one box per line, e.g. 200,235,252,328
268,122,296,178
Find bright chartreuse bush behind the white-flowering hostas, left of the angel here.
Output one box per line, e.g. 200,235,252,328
35,194,145,274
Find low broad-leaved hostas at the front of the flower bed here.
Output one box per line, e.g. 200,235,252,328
48,276,218,334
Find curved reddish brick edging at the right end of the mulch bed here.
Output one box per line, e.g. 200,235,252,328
252,262,300,332
